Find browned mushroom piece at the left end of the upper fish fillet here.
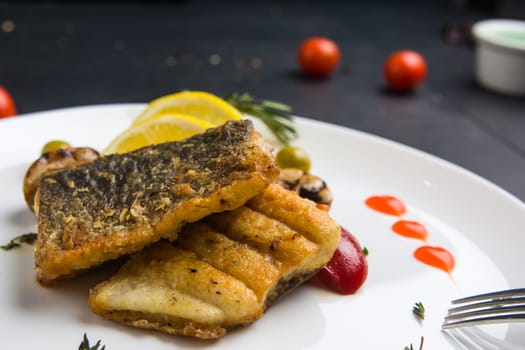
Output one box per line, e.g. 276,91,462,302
24,147,100,213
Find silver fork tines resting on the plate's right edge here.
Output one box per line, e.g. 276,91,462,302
442,288,525,329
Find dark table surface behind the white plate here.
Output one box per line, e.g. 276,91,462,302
0,1,525,200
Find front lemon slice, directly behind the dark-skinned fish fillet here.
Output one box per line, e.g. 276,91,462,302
102,114,214,154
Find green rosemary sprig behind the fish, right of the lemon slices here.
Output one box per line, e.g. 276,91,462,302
224,92,297,145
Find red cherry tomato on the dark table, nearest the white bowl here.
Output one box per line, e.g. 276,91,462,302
383,50,427,92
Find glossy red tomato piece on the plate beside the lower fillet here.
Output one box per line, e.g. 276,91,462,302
316,228,368,294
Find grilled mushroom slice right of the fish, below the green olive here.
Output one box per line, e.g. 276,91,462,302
276,168,333,207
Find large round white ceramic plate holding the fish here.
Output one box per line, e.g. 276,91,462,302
0,104,525,350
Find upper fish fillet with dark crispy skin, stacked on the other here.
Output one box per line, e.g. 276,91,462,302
35,120,279,283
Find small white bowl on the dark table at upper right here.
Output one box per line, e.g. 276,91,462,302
472,19,525,96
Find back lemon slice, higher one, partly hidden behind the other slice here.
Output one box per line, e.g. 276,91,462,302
132,91,242,126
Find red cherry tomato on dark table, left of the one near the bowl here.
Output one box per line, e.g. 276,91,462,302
297,36,341,77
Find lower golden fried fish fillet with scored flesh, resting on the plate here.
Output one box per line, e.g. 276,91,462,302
89,185,340,339
